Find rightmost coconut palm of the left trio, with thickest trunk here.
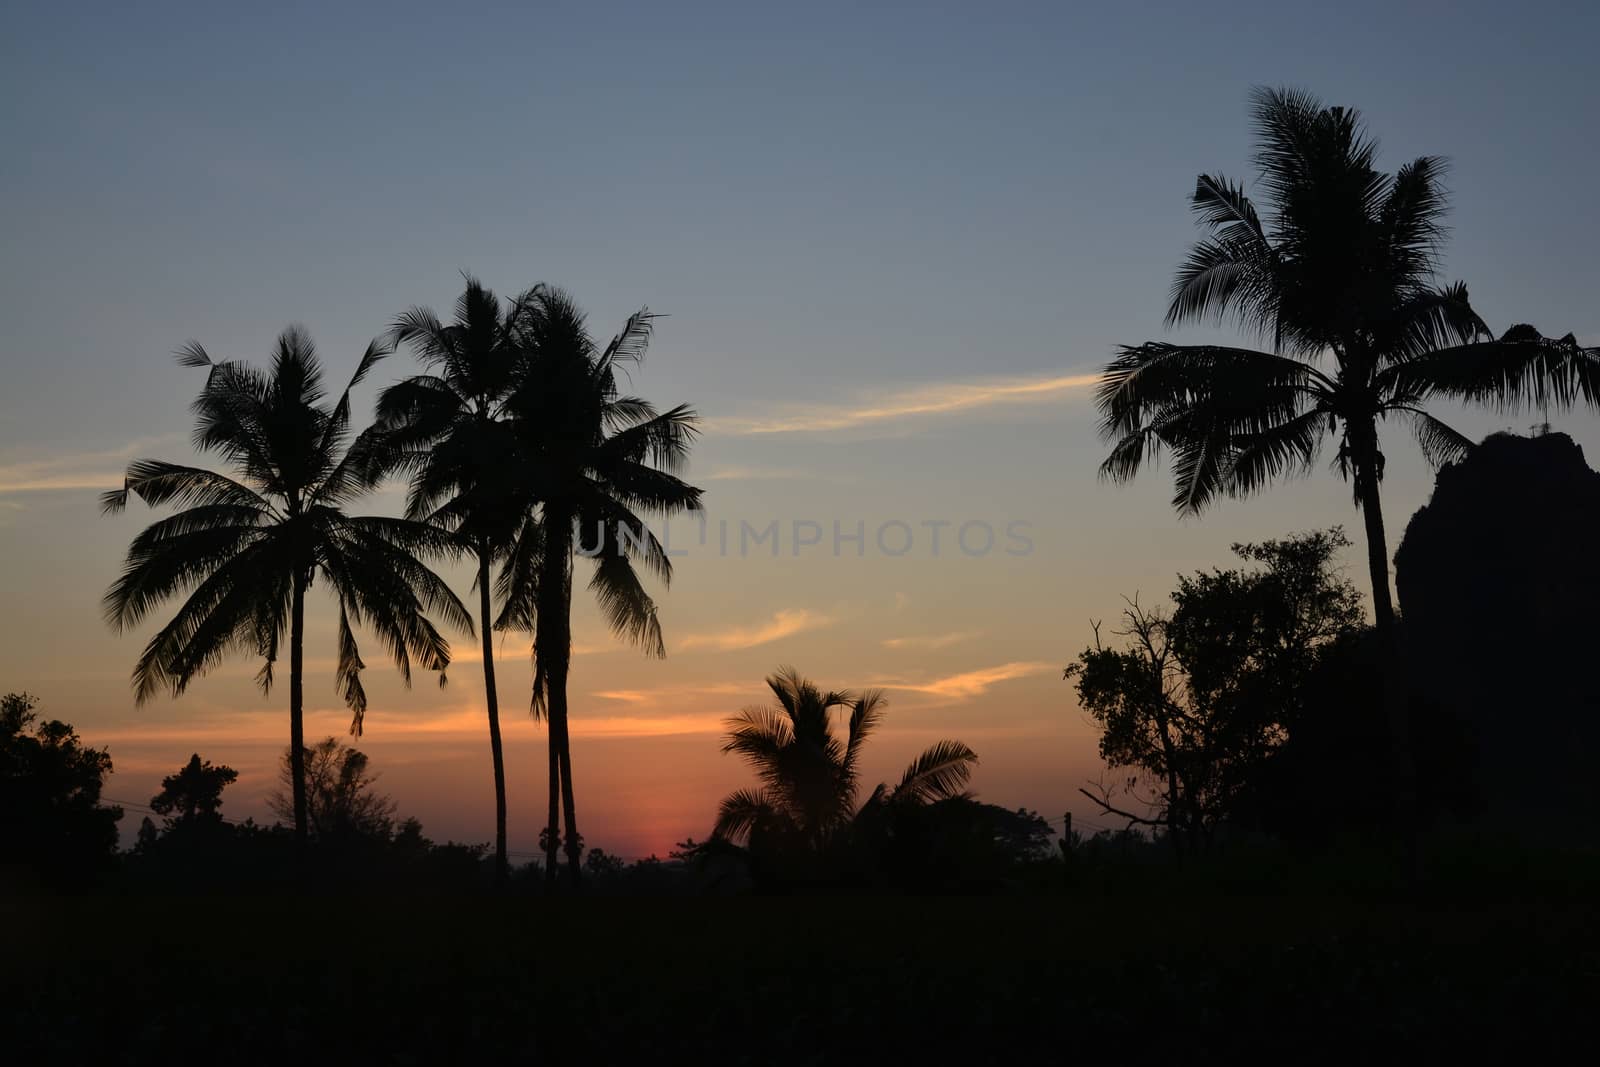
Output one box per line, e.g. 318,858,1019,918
499,286,701,881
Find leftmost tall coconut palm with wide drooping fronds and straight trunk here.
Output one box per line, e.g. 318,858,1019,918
102,326,472,845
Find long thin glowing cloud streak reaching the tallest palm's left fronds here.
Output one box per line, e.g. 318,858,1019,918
706,367,1101,435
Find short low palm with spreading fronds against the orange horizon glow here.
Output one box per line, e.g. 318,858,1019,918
712,667,978,862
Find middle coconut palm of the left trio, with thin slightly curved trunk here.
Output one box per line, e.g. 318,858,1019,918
370,277,518,878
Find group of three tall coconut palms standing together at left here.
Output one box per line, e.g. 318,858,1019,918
102,277,701,878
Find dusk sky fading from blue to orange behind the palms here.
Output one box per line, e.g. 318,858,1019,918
0,3,1600,856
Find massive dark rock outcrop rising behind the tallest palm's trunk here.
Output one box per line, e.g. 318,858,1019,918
1395,434,1600,837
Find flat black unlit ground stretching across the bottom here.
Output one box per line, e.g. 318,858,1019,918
0,886,1600,1064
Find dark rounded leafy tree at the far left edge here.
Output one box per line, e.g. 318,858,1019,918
0,693,122,888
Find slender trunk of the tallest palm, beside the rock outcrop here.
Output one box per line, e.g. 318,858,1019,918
1355,448,1418,867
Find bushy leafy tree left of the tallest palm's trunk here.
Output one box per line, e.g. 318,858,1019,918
1066,528,1362,849
